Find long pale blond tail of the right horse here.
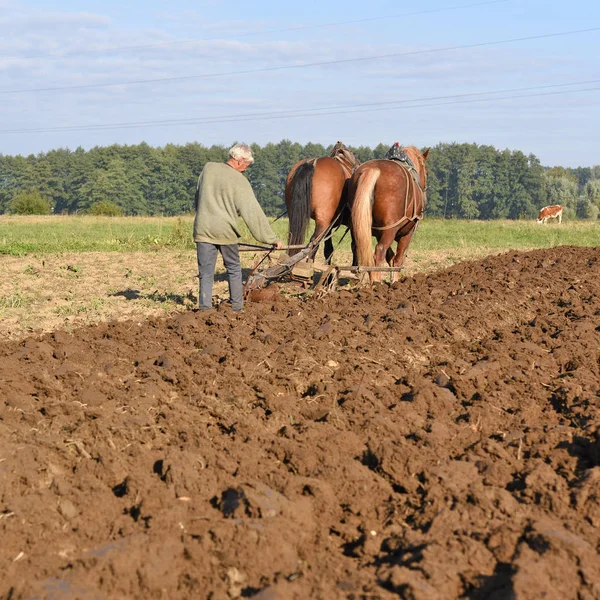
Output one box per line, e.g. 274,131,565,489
352,168,381,267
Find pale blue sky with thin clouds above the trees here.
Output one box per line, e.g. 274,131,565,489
0,0,600,166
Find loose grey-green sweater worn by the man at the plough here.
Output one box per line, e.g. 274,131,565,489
194,162,277,245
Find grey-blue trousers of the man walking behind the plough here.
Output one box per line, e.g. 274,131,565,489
196,242,244,311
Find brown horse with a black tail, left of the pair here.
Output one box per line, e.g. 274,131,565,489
285,142,360,263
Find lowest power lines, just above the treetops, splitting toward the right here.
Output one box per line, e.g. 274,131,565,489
0,79,600,135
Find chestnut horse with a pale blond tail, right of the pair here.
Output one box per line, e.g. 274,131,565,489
348,142,429,283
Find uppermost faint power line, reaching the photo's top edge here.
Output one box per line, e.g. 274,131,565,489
0,0,510,60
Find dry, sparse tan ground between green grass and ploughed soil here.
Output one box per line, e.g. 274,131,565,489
0,249,496,340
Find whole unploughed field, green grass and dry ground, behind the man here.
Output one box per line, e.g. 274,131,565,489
0,216,600,339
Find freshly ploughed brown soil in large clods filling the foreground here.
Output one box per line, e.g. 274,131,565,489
0,247,600,600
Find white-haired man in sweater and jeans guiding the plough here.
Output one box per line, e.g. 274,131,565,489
194,144,282,312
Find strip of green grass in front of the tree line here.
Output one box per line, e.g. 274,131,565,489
0,216,600,256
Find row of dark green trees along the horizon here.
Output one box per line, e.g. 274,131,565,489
0,140,600,219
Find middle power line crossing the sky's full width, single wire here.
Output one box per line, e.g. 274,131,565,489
0,27,600,95
